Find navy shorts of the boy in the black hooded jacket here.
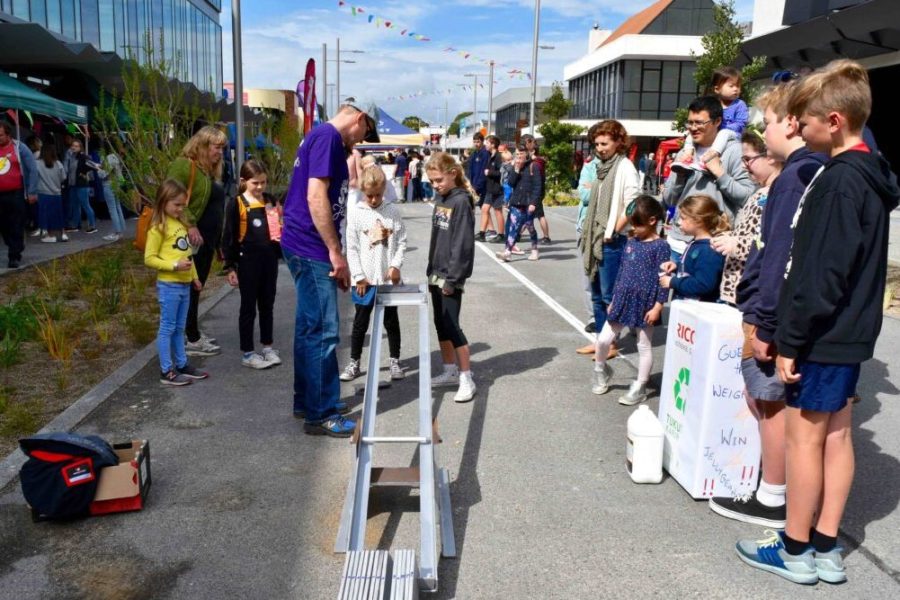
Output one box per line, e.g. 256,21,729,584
785,361,859,412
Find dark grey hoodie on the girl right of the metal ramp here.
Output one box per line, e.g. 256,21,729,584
425,188,475,291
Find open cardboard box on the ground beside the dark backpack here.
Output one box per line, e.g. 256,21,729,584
90,440,152,515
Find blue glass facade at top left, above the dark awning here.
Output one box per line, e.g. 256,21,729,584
0,0,222,96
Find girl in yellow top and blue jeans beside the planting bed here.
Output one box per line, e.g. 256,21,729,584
144,179,209,386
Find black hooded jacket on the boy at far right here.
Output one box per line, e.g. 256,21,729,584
775,150,900,364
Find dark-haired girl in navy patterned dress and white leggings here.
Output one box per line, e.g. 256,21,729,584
591,196,669,406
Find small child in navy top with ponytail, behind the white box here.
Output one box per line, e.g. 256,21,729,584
659,195,730,302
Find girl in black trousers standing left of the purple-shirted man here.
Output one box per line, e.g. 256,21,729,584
222,160,281,369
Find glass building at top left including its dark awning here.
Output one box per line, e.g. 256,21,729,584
0,0,222,96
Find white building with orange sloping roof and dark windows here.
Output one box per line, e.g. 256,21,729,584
564,0,714,150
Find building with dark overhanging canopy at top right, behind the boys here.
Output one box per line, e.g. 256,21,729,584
742,0,900,167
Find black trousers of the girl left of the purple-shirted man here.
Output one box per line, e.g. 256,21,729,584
238,249,278,352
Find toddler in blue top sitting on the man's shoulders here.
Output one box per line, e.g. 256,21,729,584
672,67,750,172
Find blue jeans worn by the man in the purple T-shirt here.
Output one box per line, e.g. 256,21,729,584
284,250,341,423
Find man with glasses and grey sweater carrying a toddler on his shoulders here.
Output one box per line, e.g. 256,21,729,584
662,96,756,263
